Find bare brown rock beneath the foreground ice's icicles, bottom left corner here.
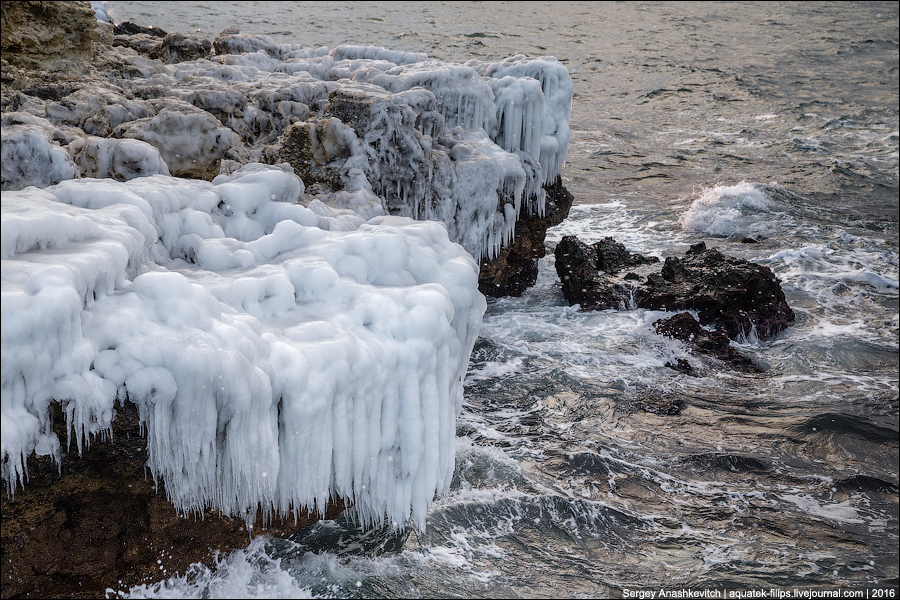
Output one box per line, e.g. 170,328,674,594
0,403,343,598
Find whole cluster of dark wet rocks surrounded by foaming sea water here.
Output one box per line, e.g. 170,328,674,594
555,236,794,375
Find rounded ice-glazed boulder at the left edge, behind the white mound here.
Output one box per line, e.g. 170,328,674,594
0,125,75,190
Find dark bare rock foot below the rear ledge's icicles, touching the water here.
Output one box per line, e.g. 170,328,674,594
478,178,574,297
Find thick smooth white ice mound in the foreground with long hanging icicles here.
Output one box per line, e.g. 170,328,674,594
0,165,485,527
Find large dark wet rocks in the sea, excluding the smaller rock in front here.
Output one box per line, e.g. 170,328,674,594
556,236,794,340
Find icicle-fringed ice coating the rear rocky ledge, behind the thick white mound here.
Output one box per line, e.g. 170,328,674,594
4,31,573,259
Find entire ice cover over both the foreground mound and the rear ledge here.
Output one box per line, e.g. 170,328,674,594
0,27,572,526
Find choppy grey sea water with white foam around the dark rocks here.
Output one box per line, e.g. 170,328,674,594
113,2,900,597
